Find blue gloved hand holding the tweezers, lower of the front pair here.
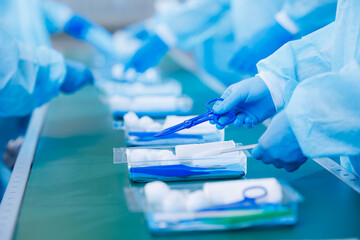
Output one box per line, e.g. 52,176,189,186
252,111,307,172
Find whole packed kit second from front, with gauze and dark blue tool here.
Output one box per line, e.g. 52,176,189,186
114,141,247,182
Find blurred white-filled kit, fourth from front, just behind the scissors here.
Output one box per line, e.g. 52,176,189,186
102,95,193,118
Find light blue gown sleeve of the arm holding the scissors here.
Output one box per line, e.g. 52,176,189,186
257,23,334,111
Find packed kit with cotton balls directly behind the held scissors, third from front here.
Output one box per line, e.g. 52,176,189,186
119,112,224,146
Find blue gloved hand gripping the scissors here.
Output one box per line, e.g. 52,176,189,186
213,76,276,129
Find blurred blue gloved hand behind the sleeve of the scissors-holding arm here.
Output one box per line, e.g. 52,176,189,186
229,22,294,73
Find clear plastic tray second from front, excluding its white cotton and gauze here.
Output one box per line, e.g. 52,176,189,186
114,144,247,182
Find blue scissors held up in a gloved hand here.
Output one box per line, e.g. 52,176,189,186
154,98,236,137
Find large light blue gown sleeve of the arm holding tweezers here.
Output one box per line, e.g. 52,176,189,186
286,60,360,157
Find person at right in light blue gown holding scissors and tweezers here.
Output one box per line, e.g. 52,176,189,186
214,0,360,175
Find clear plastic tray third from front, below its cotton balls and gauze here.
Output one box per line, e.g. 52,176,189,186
114,120,225,146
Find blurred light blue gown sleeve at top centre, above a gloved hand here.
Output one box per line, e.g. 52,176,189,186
152,0,231,50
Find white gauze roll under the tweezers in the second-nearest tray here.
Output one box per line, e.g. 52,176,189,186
175,141,240,158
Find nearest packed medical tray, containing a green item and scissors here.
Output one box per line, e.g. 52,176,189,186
124,178,303,234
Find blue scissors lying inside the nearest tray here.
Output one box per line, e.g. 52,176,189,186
198,186,268,212
